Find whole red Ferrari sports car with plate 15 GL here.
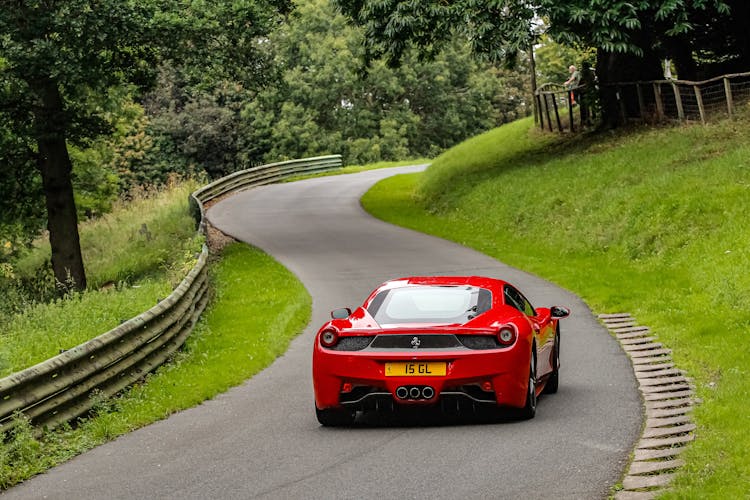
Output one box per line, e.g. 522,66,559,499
313,276,570,426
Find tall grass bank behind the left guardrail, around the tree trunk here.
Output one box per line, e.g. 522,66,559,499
0,182,203,377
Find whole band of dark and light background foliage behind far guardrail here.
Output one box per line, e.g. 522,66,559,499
140,0,528,172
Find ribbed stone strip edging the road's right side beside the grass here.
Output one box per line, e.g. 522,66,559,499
599,313,698,500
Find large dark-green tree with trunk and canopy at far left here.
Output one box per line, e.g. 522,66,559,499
0,0,288,289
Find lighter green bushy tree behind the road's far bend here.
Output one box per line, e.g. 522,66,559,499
238,0,529,163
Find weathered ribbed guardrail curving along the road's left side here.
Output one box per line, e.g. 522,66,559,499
0,155,342,433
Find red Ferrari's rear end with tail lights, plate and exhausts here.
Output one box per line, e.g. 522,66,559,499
313,325,531,412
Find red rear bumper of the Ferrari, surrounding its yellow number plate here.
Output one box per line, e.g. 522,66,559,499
313,339,531,410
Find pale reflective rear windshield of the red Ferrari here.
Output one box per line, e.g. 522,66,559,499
367,285,492,326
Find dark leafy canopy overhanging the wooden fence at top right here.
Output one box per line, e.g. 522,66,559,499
336,0,736,128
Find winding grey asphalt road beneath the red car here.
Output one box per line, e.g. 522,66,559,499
3,168,641,499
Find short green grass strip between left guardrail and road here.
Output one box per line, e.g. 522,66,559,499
0,244,311,488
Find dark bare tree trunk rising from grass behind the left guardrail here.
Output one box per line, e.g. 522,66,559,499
29,76,86,291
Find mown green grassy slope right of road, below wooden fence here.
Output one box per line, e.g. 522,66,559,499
363,119,750,498
